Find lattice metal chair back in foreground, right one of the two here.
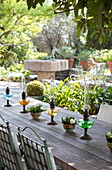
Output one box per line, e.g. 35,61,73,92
18,127,56,170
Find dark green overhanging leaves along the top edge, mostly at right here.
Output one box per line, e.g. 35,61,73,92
18,0,112,43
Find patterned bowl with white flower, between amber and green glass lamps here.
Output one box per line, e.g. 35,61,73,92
62,116,77,131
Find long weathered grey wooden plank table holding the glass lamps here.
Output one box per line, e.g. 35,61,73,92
0,94,112,170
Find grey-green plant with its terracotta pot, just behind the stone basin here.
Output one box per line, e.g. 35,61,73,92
55,46,76,68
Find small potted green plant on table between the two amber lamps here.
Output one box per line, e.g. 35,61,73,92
28,105,45,120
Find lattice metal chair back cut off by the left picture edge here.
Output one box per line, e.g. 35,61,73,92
0,115,23,170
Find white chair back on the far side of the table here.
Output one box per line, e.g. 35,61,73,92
97,104,112,124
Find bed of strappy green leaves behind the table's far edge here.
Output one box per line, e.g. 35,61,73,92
43,80,112,114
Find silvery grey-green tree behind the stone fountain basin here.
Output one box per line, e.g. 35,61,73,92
33,14,79,55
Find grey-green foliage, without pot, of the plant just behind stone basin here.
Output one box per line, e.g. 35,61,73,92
55,46,76,59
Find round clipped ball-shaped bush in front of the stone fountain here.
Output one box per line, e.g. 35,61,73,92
26,80,45,96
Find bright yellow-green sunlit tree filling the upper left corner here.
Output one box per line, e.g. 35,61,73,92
0,0,51,68
